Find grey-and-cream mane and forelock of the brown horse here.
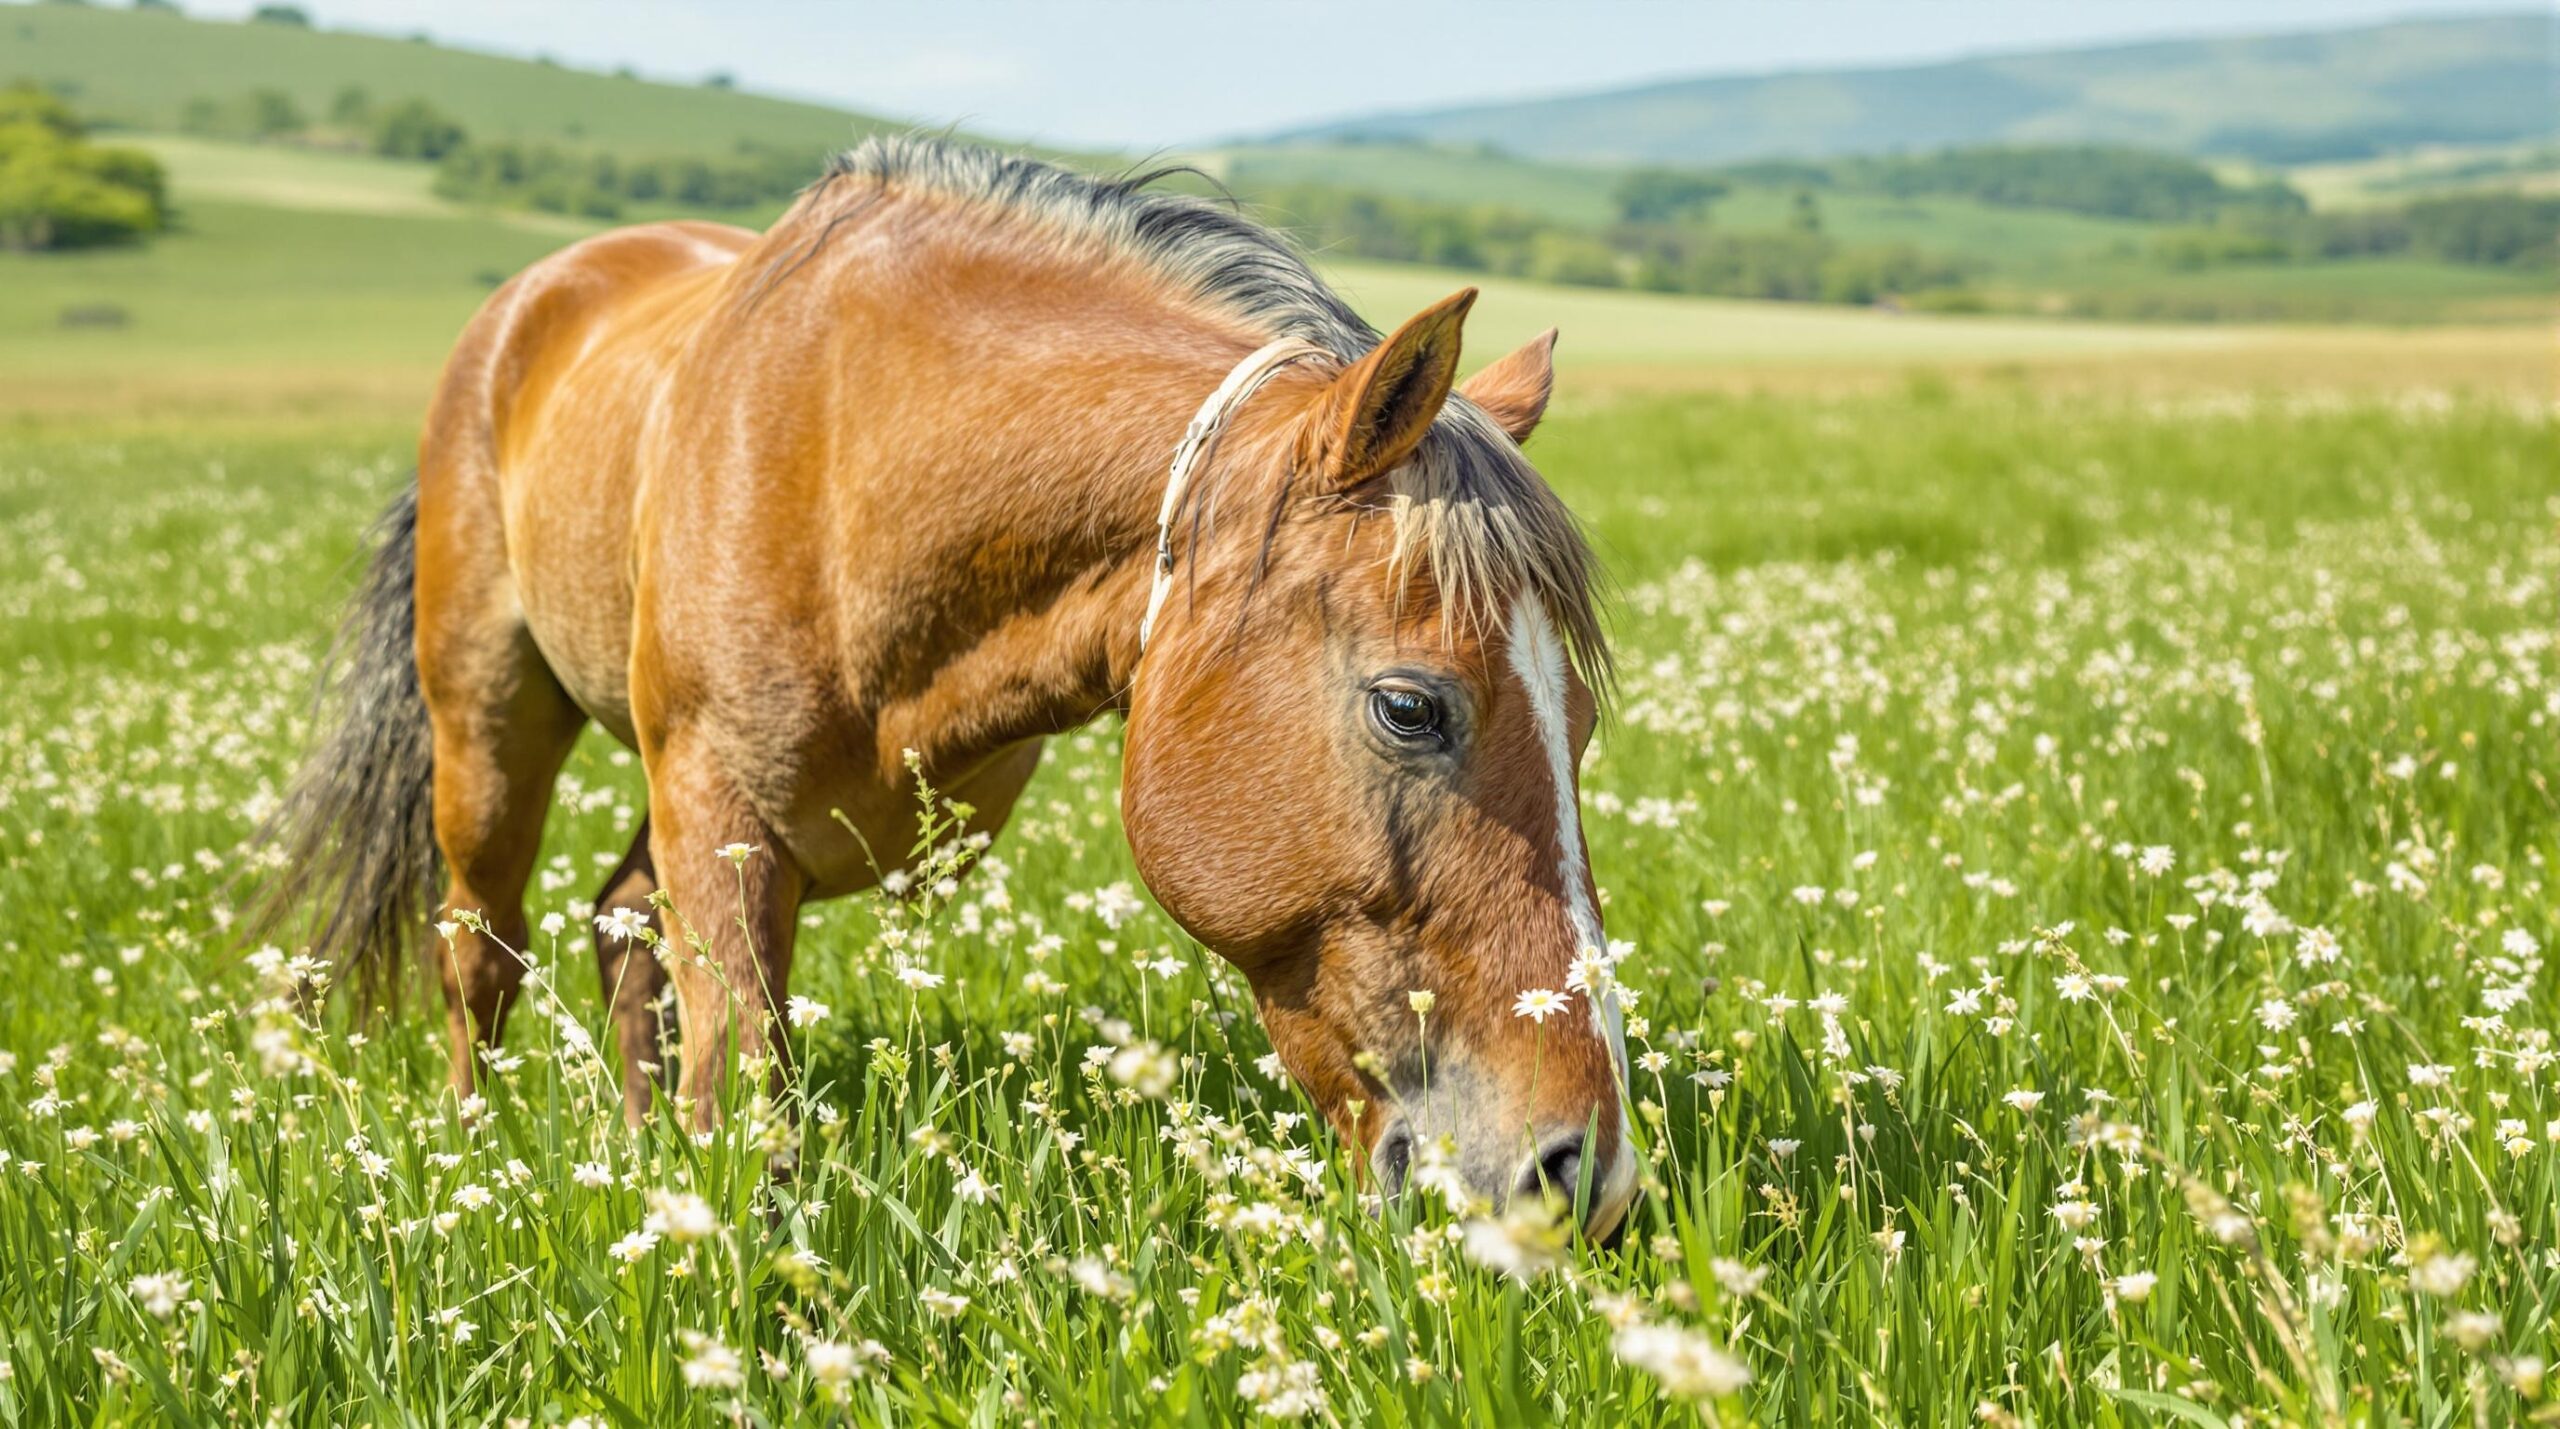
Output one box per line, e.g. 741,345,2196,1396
809,133,1608,694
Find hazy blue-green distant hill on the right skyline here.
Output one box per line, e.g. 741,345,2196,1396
1277,13,2560,164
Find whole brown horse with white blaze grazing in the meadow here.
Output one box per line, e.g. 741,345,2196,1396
249,138,1636,1232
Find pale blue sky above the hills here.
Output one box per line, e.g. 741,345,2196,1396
165,0,2550,149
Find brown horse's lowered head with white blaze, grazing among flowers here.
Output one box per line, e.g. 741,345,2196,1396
1124,289,1636,1234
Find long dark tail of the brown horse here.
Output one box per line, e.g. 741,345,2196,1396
248,481,440,996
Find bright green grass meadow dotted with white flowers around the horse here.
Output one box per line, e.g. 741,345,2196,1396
0,389,2560,1426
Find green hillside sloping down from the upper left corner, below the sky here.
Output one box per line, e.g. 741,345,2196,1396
0,5,904,154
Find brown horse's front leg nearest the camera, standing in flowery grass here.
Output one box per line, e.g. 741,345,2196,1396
648,745,806,1127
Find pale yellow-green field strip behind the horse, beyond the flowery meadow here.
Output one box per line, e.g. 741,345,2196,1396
0,151,2552,423
